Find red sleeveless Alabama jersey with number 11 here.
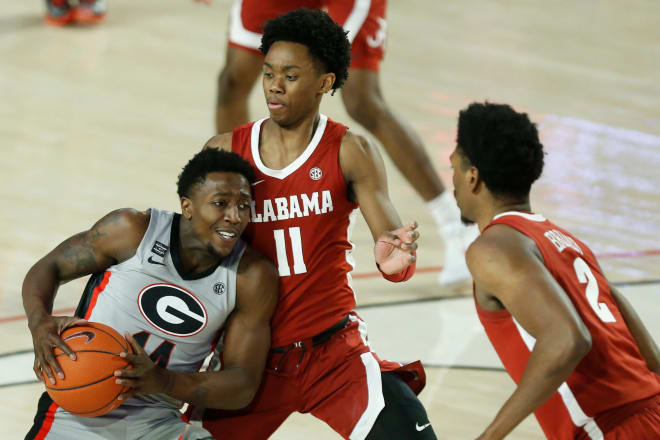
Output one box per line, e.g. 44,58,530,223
232,115,358,347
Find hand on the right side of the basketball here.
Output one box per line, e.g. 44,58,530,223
115,333,168,400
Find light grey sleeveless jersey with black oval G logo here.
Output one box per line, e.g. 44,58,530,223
76,209,245,407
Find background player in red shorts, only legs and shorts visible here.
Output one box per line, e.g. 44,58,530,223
211,0,476,285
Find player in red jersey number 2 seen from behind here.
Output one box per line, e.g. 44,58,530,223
451,103,660,440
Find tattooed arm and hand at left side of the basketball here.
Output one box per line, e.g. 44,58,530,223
23,209,149,383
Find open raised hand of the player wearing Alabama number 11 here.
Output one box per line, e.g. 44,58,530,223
374,221,419,275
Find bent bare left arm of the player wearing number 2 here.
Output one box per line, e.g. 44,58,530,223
466,225,591,440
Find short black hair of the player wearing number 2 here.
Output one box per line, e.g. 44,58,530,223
456,102,544,197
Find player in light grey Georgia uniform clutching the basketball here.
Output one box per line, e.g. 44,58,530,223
23,150,278,440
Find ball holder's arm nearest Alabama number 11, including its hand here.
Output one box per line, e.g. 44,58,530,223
115,249,279,409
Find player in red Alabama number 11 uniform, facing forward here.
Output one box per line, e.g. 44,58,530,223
204,9,435,440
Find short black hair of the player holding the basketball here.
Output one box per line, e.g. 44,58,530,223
177,148,255,198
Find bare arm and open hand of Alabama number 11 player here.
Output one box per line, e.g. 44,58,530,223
339,132,419,275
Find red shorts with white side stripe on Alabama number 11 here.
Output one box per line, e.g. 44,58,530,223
204,313,425,440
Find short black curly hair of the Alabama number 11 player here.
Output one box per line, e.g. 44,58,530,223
259,8,351,90
